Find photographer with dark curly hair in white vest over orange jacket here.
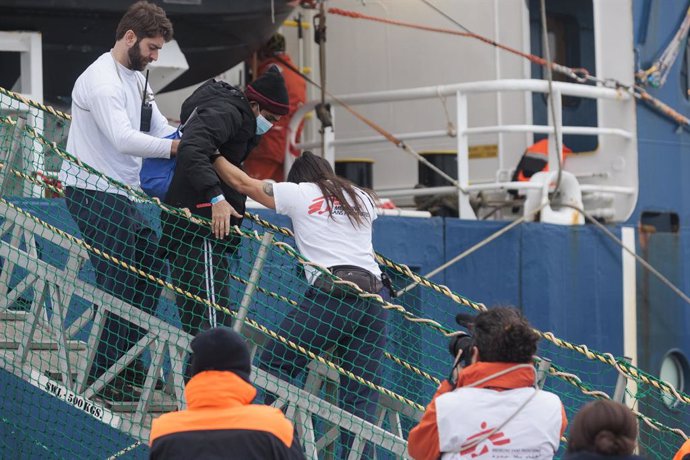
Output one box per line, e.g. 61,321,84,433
407,307,568,460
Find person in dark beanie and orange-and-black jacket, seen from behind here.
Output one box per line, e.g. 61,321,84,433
149,327,305,460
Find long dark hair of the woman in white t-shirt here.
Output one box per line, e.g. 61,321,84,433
287,151,372,226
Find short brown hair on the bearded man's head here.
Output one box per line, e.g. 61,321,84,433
115,0,173,42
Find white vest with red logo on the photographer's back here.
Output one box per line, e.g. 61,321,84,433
436,387,563,460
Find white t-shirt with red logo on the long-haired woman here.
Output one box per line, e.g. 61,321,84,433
273,182,381,283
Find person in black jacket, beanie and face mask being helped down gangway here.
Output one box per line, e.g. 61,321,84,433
161,68,289,335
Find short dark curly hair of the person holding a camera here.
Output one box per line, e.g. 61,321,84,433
472,307,539,363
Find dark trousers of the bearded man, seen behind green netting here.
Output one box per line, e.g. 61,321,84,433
65,187,165,378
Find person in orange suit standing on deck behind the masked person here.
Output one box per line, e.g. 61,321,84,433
244,33,307,182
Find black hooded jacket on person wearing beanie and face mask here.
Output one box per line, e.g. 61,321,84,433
165,80,259,225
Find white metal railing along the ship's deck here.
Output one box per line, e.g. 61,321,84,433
289,79,636,219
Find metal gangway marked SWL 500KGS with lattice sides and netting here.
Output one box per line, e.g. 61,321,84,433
0,195,414,459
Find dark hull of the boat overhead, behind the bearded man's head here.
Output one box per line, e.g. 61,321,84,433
0,0,292,102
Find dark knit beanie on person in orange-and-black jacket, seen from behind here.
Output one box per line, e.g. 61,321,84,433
191,327,252,383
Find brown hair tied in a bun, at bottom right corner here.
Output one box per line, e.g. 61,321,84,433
568,399,637,457
